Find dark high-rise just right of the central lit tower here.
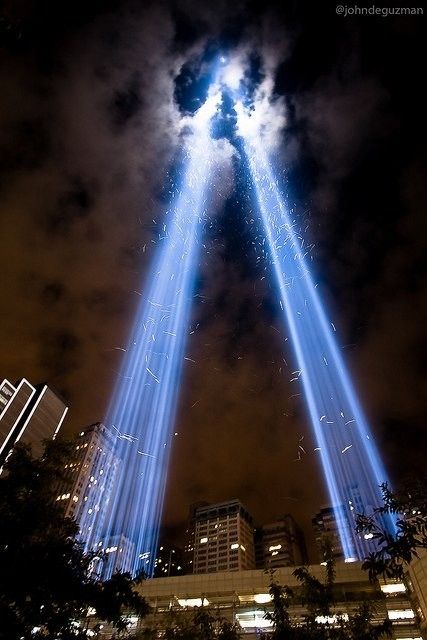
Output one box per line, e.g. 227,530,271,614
256,514,307,569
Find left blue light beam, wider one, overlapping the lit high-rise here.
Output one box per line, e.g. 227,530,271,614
80,89,224,578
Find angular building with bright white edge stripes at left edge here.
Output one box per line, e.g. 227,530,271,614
0,378,68,466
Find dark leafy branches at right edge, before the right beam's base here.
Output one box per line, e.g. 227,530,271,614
357,478,427,580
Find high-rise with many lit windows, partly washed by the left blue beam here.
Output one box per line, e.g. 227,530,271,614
57,422,120,553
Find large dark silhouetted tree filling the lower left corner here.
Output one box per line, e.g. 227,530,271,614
0,441,148,640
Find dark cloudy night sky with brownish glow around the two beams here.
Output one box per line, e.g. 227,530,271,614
0,0,427,556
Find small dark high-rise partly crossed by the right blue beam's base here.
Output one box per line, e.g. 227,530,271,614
312,506,356,562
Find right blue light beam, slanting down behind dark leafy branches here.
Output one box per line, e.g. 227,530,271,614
236,120,395,562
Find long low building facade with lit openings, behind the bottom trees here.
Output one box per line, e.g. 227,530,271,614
85,562,422,640
